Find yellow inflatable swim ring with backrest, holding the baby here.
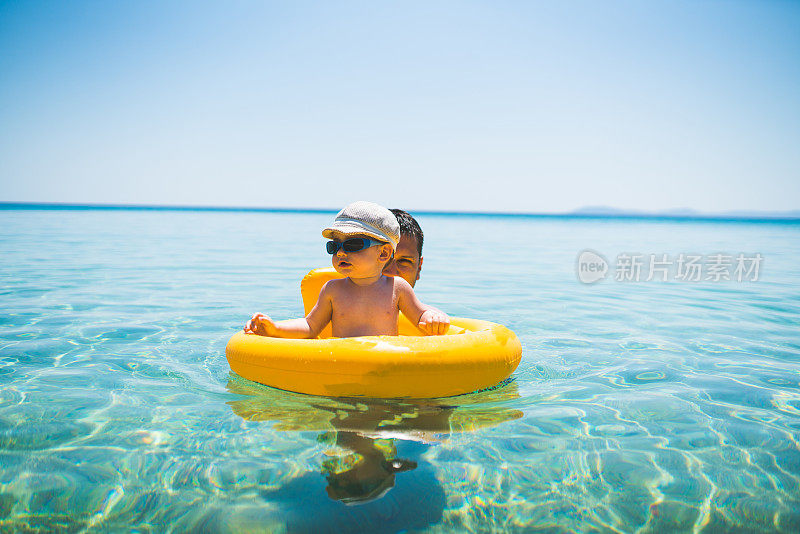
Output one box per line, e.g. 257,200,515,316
225,268,522,398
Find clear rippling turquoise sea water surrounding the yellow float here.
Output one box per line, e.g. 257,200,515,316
0,210,800,532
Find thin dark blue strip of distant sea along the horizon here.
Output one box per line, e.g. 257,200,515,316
0,200,800,222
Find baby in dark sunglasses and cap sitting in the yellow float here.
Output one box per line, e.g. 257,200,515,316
244,201,450,338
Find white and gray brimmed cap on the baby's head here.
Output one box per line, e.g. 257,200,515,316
322,200,400,248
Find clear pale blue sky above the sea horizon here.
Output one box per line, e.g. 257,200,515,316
0,0,800,212
